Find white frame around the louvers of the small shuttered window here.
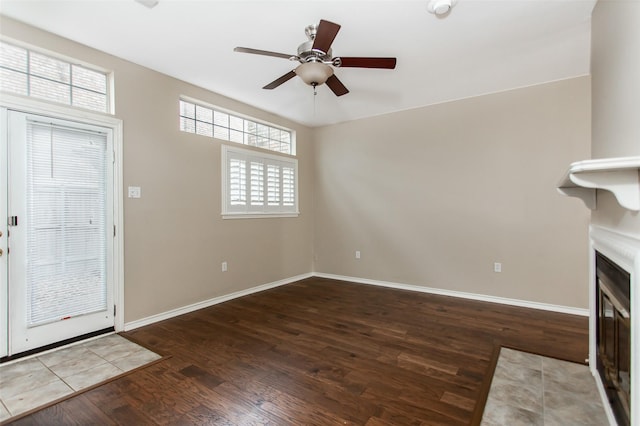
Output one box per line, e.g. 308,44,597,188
220,142,300,219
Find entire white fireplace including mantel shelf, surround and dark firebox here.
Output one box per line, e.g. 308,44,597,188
557,156,640,425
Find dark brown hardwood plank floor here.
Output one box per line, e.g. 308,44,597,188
8,278,588,426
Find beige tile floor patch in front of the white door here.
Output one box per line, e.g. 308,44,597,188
0,334,161,421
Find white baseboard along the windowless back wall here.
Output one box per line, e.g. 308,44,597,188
313,272,589,317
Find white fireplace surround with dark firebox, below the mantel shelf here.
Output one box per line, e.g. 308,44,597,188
589,225,640,426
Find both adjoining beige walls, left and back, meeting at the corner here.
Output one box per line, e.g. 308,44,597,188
0,13,590,322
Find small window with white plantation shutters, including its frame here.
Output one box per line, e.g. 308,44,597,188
222,145,298,218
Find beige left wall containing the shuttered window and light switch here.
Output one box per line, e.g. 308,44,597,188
0,17,313,322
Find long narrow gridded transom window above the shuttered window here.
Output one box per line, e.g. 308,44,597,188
180,99,295,155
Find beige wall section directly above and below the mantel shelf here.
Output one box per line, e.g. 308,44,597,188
591,0,640,236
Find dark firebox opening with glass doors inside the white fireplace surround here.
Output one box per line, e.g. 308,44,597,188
595,251,631,426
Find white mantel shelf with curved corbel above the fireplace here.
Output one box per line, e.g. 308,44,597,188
558,157,640,211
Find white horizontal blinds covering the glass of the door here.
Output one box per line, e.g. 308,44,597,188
24,122,107,326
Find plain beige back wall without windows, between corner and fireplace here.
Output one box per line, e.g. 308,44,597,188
314,77,590,308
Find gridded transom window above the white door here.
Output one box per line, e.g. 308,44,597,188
0,41,109,112
